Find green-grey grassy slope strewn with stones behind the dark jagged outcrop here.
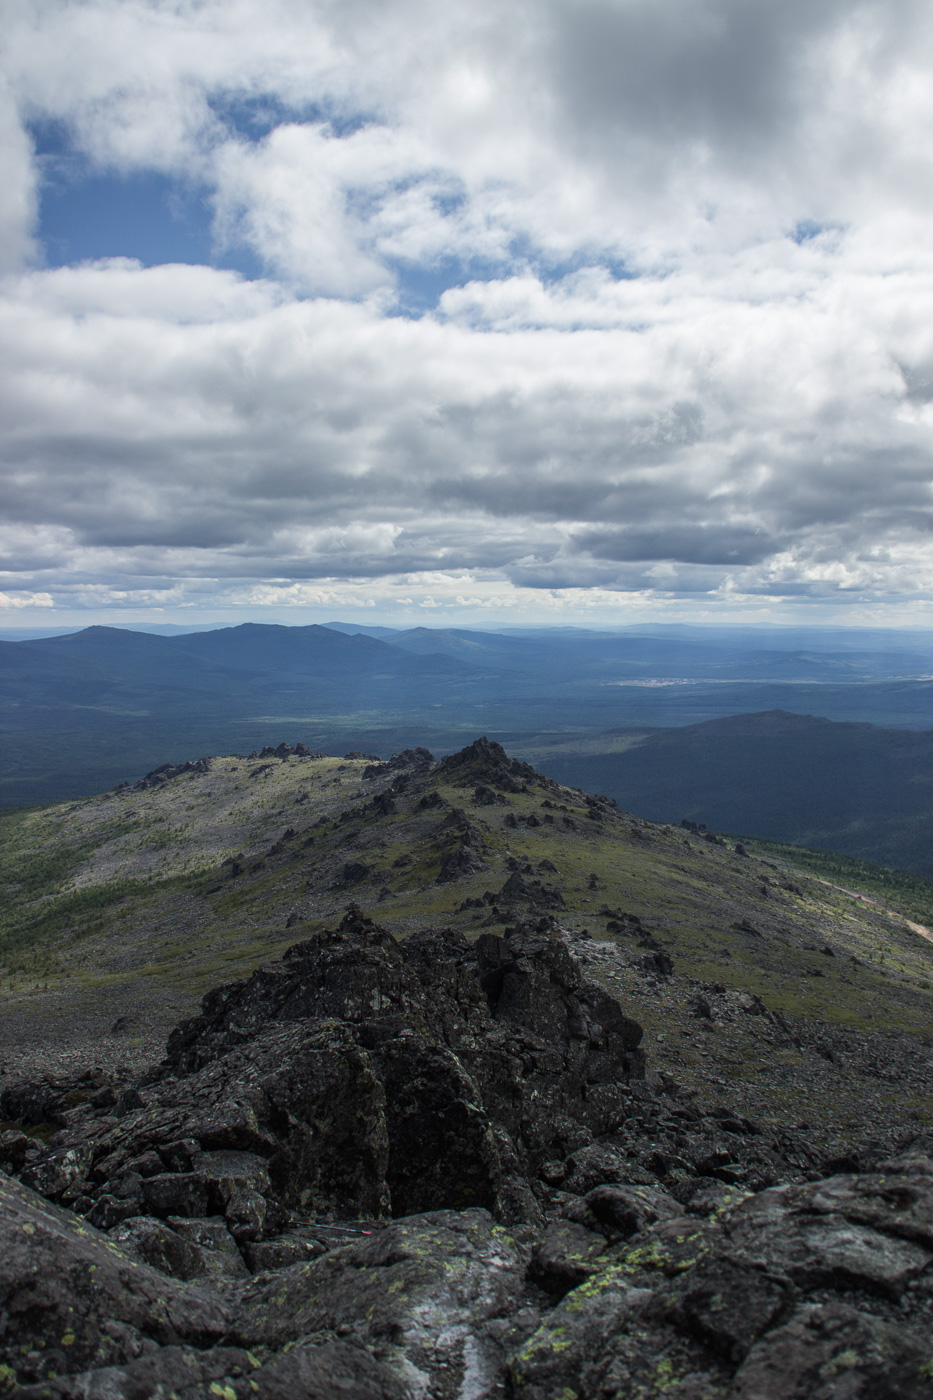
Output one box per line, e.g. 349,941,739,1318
0,757,933,1153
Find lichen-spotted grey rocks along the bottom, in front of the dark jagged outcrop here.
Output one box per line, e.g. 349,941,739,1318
0,1108,933,1400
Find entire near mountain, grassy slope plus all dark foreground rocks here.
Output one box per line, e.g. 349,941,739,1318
0,741,933,1400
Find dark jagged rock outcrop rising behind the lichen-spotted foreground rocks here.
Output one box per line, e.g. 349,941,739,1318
11,906,644,1246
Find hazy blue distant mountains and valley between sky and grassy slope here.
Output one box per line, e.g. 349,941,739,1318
0,623,933,874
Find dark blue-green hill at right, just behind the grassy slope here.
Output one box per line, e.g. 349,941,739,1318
518,710,933,875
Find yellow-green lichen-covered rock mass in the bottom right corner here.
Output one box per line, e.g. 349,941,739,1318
509,1159,933,1400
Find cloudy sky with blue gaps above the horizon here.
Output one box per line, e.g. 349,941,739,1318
0,0,933,627
